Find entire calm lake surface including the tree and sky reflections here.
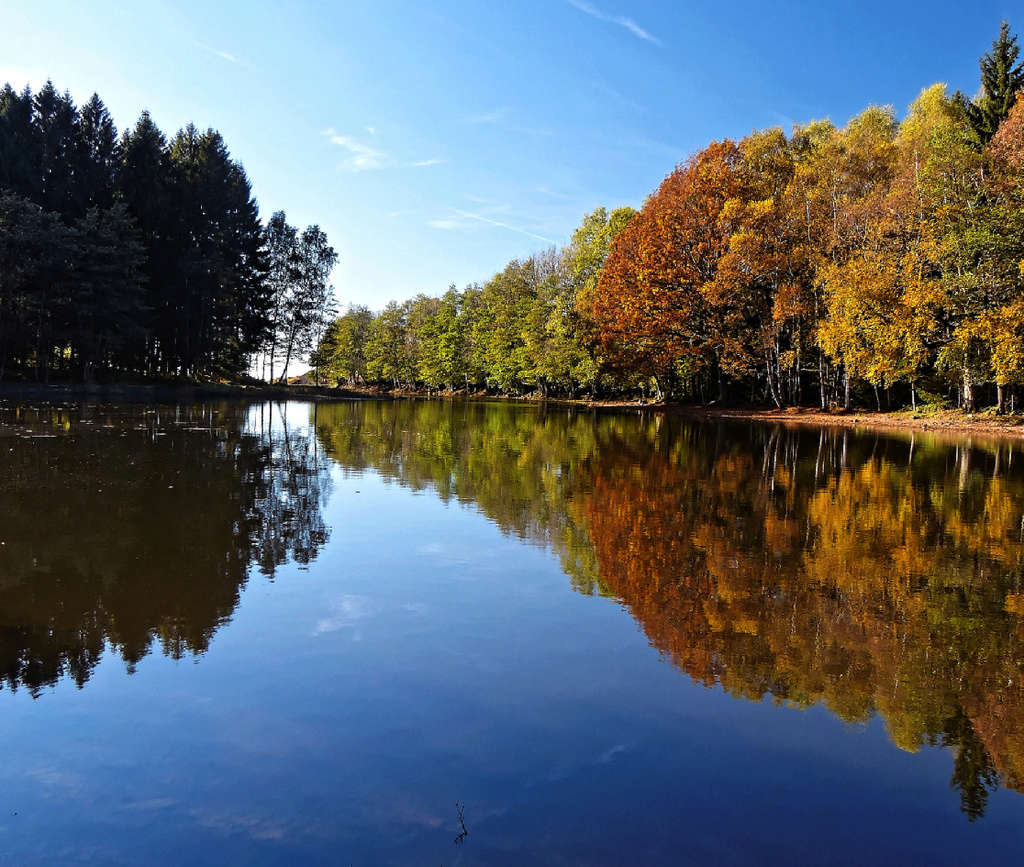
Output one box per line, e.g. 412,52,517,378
0,402,1024,865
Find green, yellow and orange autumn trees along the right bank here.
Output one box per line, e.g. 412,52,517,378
312,24,1024,411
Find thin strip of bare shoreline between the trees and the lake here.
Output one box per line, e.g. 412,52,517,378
0,382,1024,438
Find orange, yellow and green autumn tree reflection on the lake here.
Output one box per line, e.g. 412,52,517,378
317,403,1024,819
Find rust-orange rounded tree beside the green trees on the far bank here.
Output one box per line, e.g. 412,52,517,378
585,140,740,401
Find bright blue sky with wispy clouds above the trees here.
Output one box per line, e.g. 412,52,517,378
0,0,1024,308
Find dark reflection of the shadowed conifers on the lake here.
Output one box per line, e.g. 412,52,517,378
0,404,330,694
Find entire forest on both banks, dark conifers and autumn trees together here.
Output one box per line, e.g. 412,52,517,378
6,23,1024,413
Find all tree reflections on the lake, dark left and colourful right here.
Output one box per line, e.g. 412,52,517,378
0,402,1024,819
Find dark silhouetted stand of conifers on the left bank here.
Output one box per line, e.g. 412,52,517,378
0,82,337,381
